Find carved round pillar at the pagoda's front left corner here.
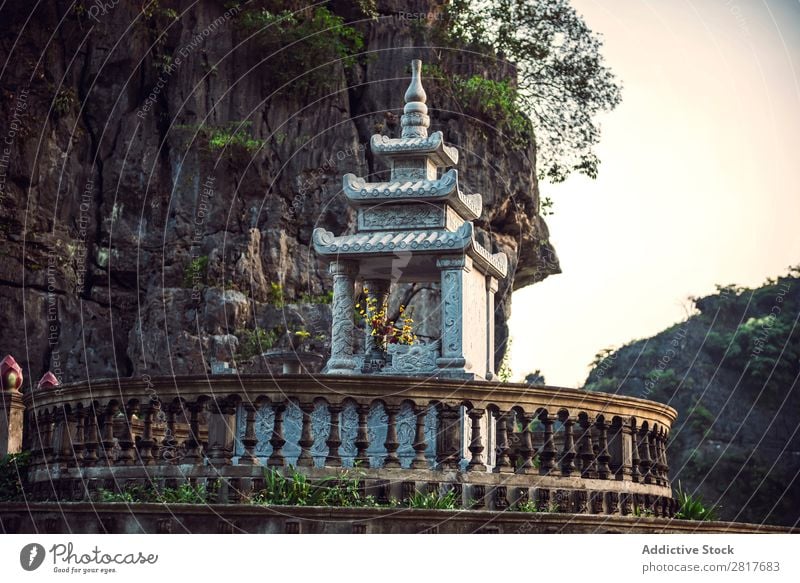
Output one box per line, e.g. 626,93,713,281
327,261,358,374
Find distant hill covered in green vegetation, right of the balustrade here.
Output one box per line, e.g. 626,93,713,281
584,268,800,525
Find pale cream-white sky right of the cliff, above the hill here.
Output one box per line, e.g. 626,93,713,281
510,0,800,386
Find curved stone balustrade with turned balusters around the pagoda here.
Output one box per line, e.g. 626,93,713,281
15,375,676,516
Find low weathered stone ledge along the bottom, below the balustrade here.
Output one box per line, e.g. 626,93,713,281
0,502,797,534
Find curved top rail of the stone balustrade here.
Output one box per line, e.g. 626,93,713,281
24,374,677,427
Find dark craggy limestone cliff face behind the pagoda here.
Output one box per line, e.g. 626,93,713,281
0,0,558,382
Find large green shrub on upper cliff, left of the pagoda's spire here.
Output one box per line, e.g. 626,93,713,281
237,1,370,93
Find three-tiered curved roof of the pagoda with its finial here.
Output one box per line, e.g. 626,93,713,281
313,61,508,279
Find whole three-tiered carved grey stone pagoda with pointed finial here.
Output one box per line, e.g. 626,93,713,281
314,60,508,379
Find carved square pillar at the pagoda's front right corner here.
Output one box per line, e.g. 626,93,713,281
436,256,472,373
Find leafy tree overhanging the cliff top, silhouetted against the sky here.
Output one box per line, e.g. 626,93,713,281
447,0,621,182
